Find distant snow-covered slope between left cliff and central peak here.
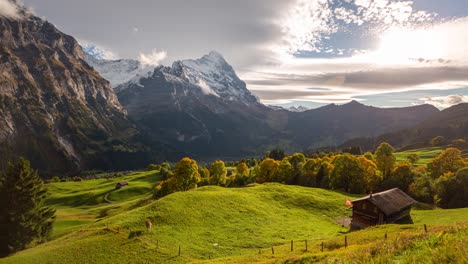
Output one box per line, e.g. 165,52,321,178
83,49,153,88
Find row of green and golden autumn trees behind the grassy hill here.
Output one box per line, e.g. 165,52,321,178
152,143,468,208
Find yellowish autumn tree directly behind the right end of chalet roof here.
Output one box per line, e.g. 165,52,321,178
382,162,416,193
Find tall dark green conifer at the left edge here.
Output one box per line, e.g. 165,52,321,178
0,158,55,256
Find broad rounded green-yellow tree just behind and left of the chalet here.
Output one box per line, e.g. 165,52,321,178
330,154,365,193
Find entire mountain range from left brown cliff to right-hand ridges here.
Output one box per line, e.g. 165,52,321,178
0,3,460,174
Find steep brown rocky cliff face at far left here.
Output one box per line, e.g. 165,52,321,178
0,12,150,173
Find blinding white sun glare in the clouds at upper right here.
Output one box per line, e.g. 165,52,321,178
376,29,445,64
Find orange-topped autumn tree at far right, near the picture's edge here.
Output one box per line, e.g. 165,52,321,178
427,148,465,179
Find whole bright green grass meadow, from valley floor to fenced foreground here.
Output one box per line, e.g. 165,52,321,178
0,171,468,264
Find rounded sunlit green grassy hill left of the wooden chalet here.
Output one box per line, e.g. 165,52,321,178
0,183,356,263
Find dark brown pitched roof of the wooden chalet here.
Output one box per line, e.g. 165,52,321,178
351,188,416,216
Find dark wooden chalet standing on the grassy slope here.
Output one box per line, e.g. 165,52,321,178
351,188,416,229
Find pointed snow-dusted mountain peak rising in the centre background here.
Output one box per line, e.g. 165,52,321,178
117,52,281,158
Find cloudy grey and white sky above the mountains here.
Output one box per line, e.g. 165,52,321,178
13,0,468,109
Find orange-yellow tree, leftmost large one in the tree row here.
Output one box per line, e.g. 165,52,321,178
174,157,201,191
